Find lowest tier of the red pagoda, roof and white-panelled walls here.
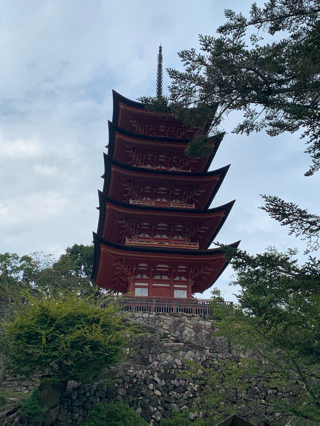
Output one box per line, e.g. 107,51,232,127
94,234,235,297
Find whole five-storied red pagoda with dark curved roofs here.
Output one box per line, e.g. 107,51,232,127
93,49,238,299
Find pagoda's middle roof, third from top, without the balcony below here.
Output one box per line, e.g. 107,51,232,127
102,154,230,209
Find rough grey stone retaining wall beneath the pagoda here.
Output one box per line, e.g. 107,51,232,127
0,313,311,426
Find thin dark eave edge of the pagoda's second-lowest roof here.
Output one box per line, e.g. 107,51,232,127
97,191,235,249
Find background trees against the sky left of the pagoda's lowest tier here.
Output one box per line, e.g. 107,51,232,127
0,244,96,312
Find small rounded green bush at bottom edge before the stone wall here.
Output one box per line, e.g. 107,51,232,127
84,401,148,426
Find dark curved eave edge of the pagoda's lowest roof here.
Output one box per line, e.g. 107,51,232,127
92,232,240,280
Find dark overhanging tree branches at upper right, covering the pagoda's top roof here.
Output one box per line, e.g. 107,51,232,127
141,0,320,175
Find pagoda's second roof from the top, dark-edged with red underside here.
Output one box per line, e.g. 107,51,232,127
107,121,222,172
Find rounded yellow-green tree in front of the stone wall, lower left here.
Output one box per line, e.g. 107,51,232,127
2,291,124,424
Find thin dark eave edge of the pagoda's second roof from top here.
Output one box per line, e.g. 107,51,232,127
106,121,223,172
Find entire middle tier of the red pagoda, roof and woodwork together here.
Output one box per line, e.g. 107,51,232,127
103,155,229,209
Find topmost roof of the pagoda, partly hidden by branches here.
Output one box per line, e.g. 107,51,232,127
112,90,203,139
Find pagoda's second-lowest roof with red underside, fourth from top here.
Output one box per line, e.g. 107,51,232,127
97,191,234,249
